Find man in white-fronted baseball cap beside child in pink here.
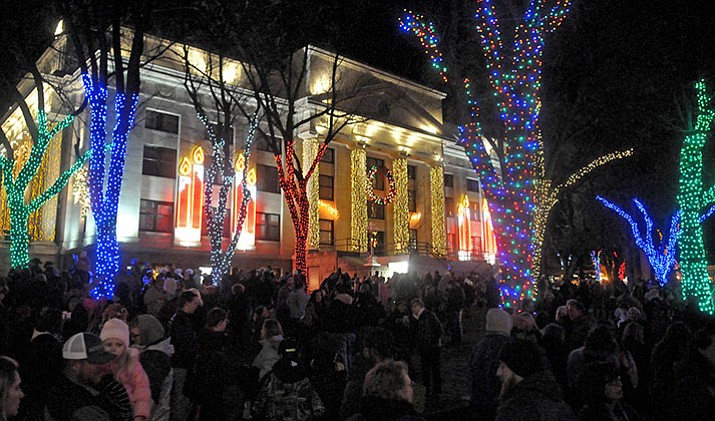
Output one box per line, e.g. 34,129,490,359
47,332,131,421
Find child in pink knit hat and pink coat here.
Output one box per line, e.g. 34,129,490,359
99,319,152,421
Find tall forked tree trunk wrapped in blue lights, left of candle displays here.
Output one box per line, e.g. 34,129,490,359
82,73,139,299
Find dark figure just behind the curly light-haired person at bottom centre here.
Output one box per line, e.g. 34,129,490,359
340,328,395,418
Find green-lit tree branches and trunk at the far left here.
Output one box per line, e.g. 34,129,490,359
0,108,92,268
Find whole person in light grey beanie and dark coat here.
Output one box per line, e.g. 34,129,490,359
469,308,513,419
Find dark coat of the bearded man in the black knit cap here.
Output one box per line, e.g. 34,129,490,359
495,371,578,421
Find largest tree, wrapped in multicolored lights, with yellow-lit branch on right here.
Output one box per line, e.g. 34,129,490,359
400,0,631,306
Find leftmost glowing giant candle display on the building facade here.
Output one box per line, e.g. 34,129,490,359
174,146,204,246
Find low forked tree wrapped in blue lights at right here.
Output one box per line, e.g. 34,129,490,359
596,196,680,285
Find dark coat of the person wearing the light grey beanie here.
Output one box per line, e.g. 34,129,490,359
469,333,511,414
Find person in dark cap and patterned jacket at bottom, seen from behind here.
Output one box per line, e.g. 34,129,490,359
252,340,325,421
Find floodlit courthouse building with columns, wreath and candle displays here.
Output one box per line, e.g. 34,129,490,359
0,32,495,283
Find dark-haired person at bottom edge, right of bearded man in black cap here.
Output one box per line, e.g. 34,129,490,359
578,362,641,421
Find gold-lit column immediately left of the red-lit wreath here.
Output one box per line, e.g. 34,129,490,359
350,148,368,249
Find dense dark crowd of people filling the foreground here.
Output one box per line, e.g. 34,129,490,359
0,260,715,421
